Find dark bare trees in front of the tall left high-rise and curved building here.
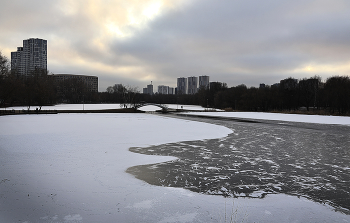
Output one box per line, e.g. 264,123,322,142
0,52,99,109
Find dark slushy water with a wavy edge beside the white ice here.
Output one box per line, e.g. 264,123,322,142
127,114,350,214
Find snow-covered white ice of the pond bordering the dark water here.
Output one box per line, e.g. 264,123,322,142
0,114,350,222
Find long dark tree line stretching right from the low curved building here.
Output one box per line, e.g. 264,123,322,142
89,76,350,115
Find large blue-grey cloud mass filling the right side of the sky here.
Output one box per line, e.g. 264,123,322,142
110,1,350,85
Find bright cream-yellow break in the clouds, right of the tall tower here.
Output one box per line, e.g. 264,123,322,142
49,0,181,87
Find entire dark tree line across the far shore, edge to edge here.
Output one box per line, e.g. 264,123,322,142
0,52,350,115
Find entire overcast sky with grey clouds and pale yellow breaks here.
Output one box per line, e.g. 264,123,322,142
0,0,350,91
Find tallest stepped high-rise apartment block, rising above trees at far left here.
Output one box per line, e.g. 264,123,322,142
11,38,47,75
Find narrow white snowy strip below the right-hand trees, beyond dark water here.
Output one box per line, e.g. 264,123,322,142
186,112,350,125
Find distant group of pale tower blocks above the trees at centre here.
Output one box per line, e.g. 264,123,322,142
143,76,210,94
